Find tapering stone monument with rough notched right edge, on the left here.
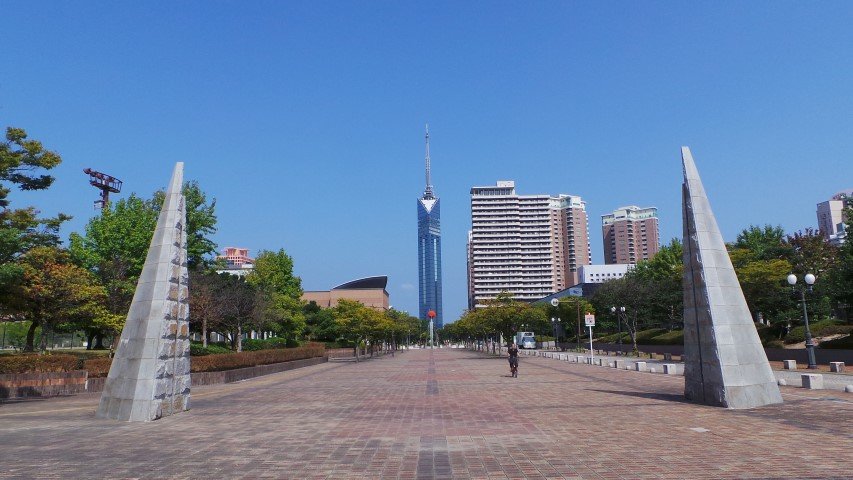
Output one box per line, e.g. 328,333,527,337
97,163,190,422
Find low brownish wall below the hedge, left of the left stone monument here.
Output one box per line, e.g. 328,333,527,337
0,370,89,400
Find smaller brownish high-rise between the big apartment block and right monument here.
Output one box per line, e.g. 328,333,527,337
601,205,660,264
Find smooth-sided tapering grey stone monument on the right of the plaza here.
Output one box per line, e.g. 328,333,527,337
681,147,782,408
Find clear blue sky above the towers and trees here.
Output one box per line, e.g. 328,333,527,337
0,1,853,321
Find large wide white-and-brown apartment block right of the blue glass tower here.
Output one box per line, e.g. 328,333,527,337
468,181,590,308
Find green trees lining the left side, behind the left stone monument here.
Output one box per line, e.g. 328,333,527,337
0,128,423,351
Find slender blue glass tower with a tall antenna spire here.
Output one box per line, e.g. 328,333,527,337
418,125,444,328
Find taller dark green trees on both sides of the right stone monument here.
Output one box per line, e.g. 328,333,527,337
592,218,853,344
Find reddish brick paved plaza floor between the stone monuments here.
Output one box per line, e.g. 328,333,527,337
0,349,853,479
